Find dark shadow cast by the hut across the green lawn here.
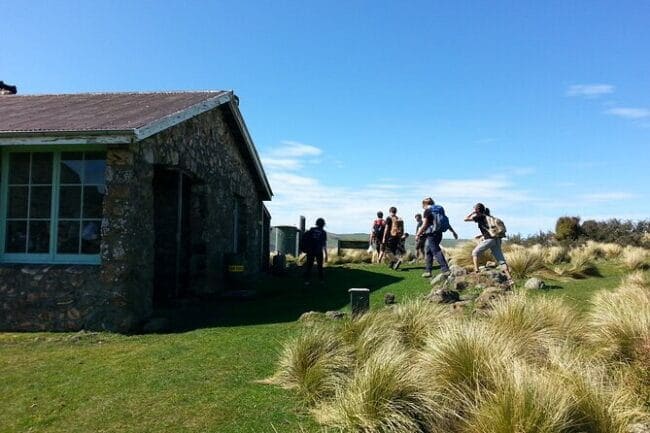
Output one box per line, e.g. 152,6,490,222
155,266,403,332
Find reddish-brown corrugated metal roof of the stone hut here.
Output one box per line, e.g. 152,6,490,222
0,91,229,133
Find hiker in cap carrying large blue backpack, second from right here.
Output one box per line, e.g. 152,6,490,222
416,197,458,278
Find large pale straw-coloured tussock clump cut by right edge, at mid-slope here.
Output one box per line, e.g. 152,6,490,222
587,286,650,362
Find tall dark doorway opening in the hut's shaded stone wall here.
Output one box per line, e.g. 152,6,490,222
153,166,192,307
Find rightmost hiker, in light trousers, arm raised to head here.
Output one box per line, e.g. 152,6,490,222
465,203,512,284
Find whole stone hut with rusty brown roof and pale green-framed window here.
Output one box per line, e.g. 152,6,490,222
0,91,272,332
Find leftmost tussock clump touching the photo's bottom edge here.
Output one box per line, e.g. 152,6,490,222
314,345,438,433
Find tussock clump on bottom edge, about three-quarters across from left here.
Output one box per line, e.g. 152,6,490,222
460,364,571,433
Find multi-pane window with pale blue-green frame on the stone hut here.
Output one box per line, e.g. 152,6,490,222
0,149,106,263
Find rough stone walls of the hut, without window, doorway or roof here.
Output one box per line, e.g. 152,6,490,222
0,104,263,332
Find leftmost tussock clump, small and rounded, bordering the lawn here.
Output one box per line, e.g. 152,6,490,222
264,324,354,404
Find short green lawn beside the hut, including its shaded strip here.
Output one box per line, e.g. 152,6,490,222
0,264,622,433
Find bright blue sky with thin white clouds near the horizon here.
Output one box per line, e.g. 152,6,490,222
0,0,650,236
